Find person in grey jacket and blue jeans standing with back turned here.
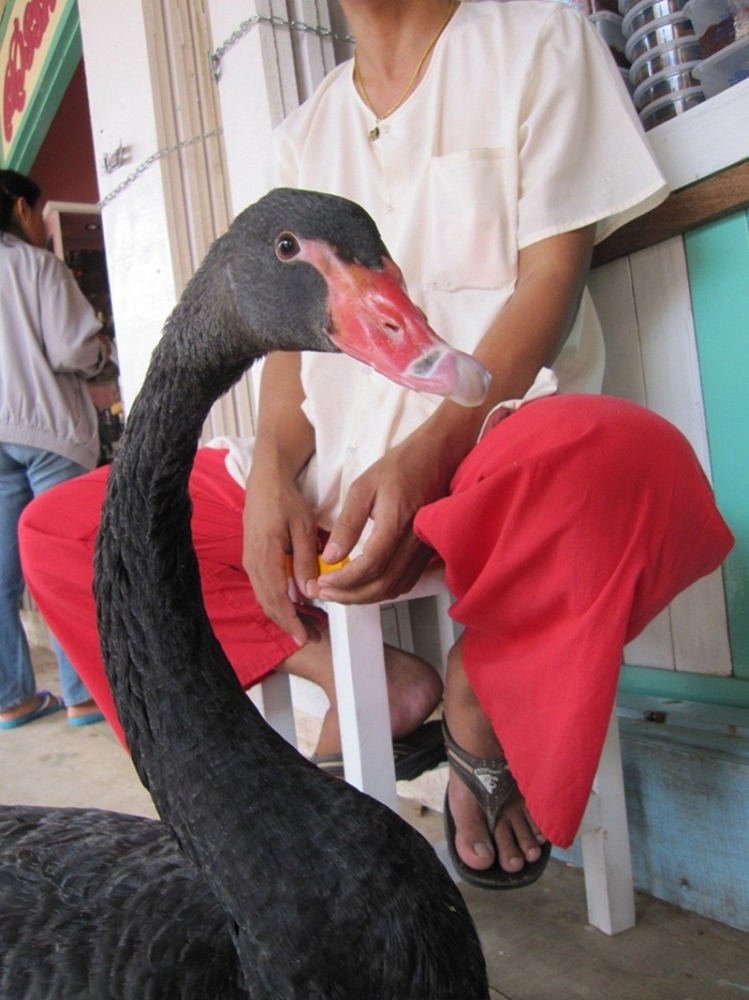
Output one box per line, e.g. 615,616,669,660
0,170,108,729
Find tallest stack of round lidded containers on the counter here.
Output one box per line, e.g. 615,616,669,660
619,0,705,129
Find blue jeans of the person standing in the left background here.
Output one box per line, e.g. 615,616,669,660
0,442,91,712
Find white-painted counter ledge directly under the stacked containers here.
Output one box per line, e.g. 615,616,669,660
647,80,749,191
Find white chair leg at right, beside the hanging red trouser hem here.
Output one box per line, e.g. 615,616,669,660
579,711,635,934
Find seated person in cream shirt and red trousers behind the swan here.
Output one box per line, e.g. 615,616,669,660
23,0,731,888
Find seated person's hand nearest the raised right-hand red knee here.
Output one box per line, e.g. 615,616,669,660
316,432,452,604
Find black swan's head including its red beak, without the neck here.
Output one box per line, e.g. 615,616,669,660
219,188,490,406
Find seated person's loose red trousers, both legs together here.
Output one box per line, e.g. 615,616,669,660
21,395,733,846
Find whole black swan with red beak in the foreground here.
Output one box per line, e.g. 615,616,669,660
0,189,489,1000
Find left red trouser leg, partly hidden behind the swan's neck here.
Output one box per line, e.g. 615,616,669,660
19,448,299,744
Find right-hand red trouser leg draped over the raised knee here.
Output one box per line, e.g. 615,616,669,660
416,396,733,847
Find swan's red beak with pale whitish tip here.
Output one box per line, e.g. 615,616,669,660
302,240,491,406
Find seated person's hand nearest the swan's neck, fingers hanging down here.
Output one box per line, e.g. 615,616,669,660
242,469,319,646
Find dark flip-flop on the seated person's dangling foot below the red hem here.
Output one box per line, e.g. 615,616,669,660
442,716,551,889
